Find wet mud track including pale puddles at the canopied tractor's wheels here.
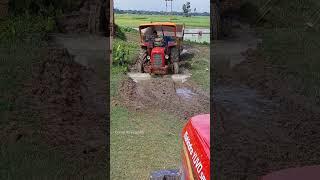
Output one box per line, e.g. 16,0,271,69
119,41,210,119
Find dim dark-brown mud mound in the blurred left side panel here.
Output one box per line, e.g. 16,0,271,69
32,48,107,160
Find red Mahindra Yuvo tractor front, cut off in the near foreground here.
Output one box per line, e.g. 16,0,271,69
150,114,210,180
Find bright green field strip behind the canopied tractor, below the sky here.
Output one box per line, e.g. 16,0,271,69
115,14,210,28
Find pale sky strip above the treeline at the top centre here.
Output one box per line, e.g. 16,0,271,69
114,0,210,12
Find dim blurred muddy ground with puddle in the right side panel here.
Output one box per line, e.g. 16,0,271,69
213,21,320,179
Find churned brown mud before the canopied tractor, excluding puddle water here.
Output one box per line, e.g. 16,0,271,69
119,77,210,118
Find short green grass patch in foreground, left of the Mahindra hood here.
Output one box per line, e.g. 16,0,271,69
110,107,184,180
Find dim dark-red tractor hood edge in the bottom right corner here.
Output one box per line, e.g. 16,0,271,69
260,166,320,180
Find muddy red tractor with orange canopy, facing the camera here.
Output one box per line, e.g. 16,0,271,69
136,22,184,75
